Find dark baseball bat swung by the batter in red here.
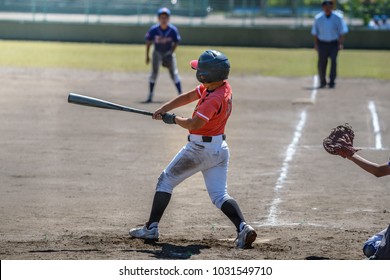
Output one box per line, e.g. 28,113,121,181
68,93,153,116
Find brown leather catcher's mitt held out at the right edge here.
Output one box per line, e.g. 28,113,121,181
323,123,359,158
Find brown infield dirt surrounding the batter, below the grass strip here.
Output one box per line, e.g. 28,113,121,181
0,68,390,260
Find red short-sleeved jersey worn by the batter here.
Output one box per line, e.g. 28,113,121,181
190,81,232,136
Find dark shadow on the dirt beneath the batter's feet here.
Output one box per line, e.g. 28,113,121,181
125,241,210,260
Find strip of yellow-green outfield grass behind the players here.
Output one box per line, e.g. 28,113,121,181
0,41,390,80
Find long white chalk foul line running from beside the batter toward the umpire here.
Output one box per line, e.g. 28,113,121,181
262,75,318,226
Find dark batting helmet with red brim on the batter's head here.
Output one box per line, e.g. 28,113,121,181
191,50,230,83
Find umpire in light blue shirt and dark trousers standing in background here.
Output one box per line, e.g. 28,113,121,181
311,1,348,88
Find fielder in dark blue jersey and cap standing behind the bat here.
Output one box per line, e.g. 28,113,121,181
145,8,181,103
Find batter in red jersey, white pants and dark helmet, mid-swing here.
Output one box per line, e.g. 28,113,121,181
129,50,257,249
